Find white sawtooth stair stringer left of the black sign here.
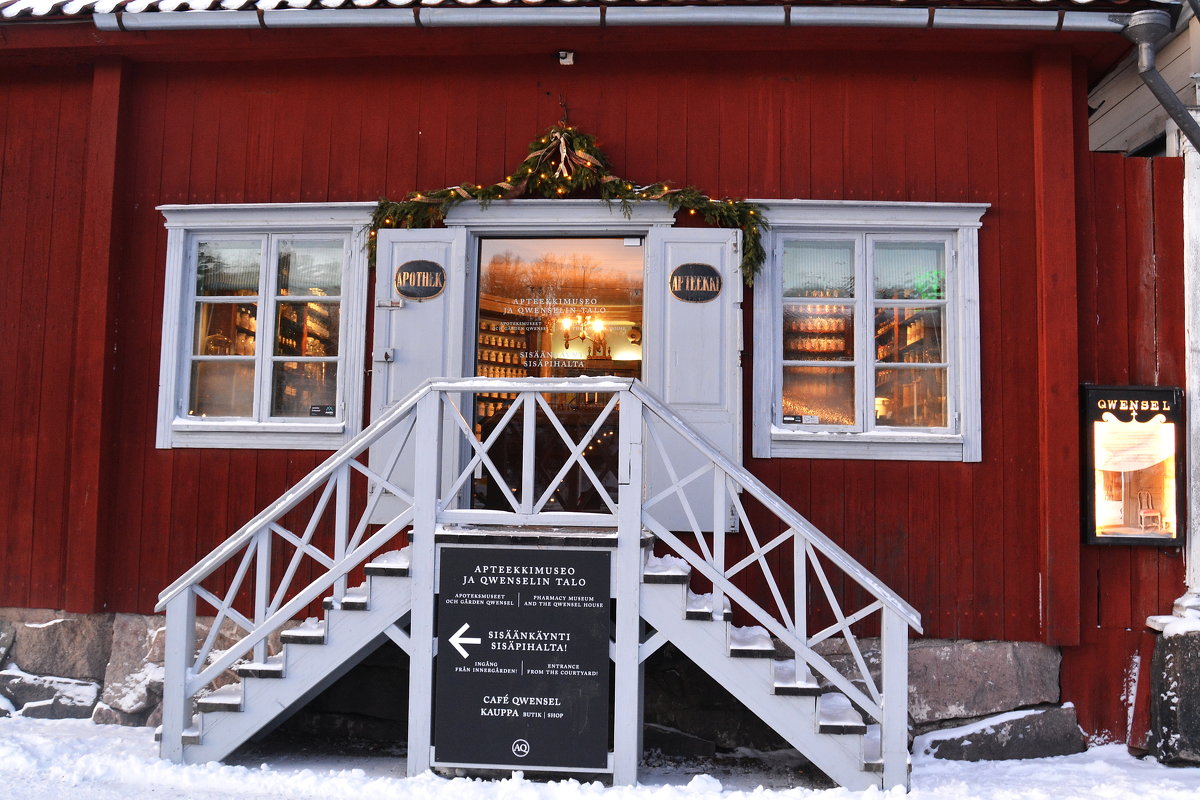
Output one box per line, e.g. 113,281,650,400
177,576,412,764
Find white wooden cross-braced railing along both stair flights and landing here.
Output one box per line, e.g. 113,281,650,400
157,378,920,787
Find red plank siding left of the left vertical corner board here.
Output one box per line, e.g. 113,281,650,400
0,67,92,607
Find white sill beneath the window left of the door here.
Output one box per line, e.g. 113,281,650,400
157,420,354,450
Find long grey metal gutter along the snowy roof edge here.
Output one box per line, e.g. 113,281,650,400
92,6,1132,34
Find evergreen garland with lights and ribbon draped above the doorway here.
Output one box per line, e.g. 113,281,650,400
370,122,768,284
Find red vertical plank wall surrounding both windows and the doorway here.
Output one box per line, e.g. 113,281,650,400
0,30,1182,734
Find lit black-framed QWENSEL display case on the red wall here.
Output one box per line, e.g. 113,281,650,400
1081,386,1186,547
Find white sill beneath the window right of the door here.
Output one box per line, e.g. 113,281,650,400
755,426,977,462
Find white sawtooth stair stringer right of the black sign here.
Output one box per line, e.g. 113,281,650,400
641,583,882,792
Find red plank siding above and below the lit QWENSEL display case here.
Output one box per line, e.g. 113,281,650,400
1063,154,1184,741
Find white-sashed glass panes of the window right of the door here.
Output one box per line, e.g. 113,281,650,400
778,234,954,431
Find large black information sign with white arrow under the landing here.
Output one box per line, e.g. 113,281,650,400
433,547,612,770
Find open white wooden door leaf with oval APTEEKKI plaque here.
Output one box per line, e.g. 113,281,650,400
643,228,742,530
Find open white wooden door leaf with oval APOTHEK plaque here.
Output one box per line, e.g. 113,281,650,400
370,228,474,523
